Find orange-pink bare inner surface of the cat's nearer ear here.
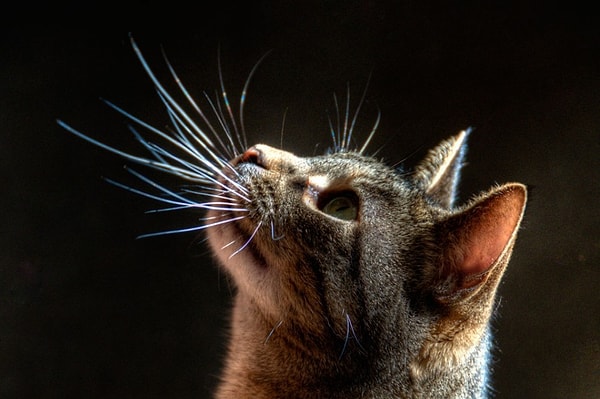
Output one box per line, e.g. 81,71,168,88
454,185,526,280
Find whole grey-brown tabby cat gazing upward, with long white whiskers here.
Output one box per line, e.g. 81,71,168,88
58,39,527,399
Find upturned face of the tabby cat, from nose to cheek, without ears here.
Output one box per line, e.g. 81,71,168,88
208,145,420,337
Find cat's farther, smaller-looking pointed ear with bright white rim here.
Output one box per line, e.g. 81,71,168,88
413,129,471,209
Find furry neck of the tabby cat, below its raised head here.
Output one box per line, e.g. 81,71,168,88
216,293,490,399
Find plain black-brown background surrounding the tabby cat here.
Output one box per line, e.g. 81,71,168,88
0,1,600,399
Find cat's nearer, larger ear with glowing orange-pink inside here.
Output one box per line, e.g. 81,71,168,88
434,183,527,302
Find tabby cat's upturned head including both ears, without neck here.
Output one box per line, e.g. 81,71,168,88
208,132,527,384
